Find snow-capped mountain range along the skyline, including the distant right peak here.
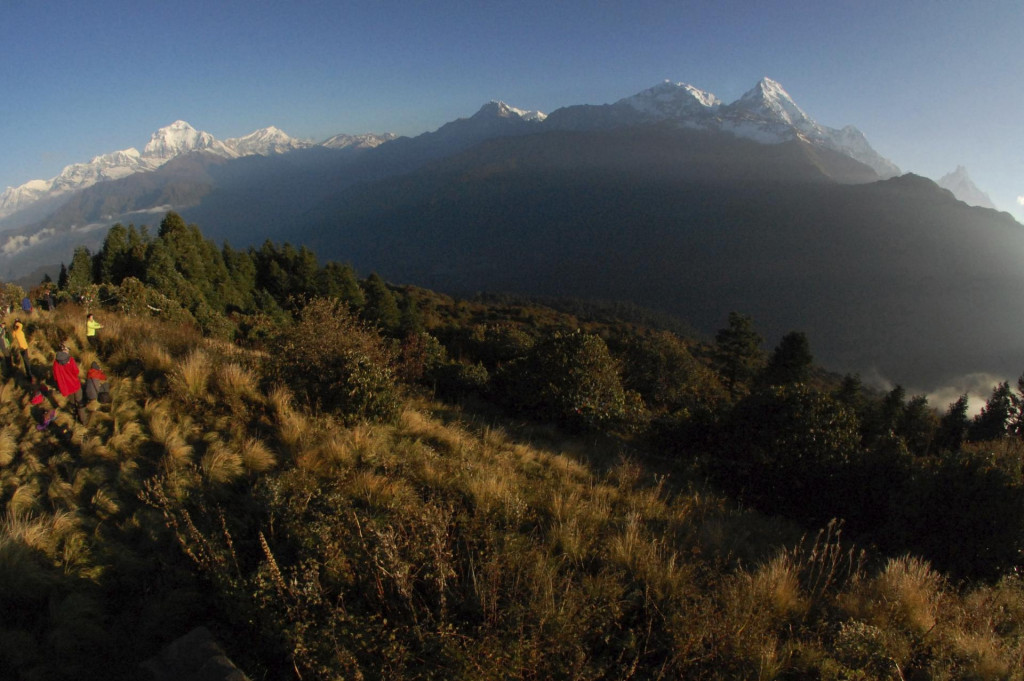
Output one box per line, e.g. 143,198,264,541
0,78,991,229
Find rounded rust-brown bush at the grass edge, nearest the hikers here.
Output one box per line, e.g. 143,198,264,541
269,298,399,422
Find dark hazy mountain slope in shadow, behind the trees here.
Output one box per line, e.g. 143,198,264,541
290,128,1024,388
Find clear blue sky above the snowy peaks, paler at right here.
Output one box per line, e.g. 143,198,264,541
0,0,1024,221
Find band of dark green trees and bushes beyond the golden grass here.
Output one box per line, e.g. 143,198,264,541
49,213,1024,579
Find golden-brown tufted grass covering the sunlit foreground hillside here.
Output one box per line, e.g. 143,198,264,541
0,293,1024,679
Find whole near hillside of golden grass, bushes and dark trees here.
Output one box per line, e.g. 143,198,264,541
0,213,1024,680
